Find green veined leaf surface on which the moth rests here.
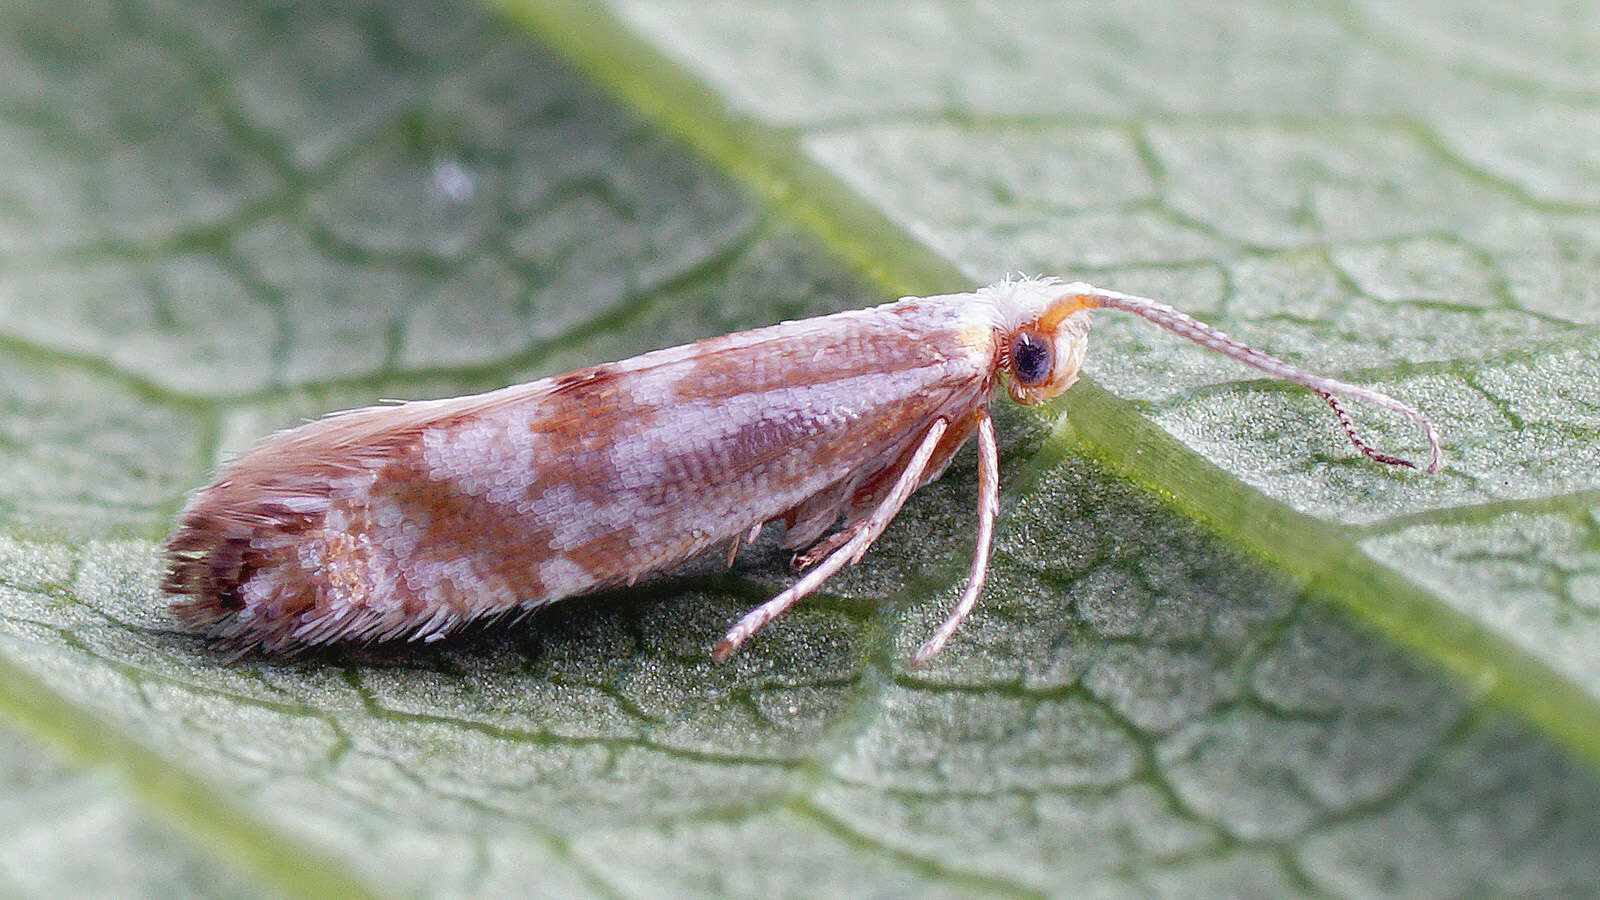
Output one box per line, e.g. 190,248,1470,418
0,0,1600,897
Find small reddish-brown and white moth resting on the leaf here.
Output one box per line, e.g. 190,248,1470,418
163,279,1440,663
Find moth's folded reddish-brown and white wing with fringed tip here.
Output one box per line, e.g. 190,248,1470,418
166,297,989,649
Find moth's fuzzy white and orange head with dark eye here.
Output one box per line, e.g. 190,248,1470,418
984,279,1094,398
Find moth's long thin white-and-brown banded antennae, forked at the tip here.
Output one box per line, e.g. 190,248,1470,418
1078,288,1442,472
